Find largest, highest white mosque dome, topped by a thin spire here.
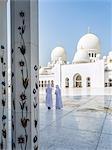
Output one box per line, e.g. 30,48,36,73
77,33,100,52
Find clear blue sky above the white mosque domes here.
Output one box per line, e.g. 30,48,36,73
39,0,112,66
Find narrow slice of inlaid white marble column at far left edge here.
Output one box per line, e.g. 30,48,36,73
0,0,8,150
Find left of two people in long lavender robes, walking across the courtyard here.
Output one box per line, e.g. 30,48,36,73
46,84,52,109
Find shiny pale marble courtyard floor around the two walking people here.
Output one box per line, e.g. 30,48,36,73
39,88,112,150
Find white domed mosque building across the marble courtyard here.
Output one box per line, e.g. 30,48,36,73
39,33,112,88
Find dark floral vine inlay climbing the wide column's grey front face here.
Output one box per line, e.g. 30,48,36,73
18,11,30,150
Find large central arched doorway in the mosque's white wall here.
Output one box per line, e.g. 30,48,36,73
73,73,82,88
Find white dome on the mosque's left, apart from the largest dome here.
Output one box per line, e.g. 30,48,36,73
51,47,67,62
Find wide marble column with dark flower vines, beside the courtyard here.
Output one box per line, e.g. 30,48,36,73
11,0,39,150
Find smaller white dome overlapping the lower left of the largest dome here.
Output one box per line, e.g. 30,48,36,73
73,50,90,63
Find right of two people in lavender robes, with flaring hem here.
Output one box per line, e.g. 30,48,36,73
55,85,63,109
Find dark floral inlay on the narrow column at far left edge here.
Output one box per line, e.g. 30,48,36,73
0,45,7,150
